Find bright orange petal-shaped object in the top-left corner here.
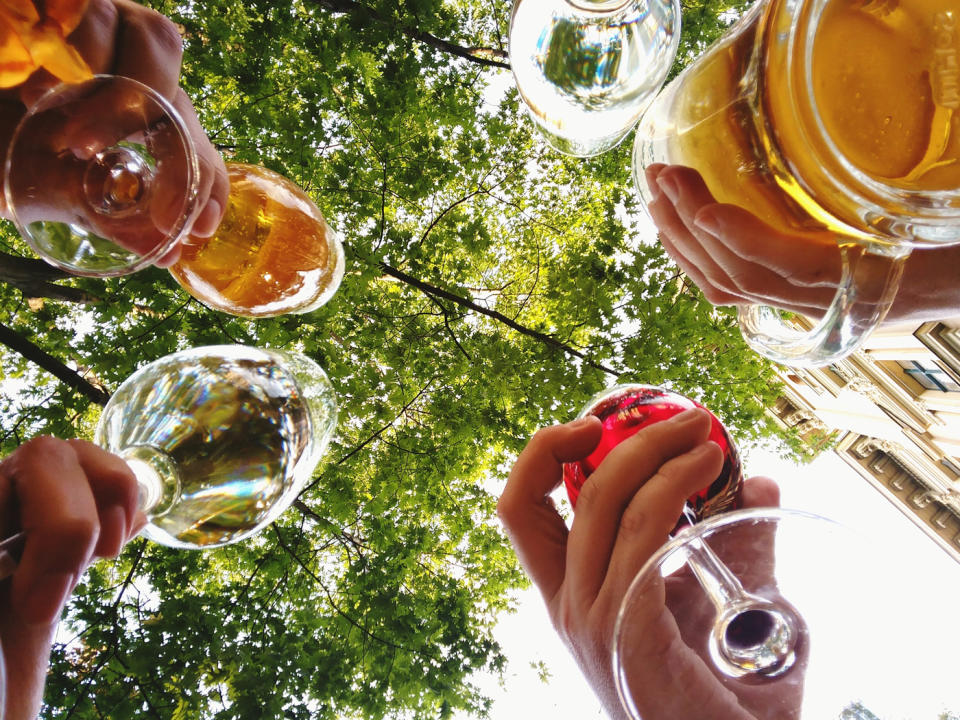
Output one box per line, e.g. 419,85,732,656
0,0,93,88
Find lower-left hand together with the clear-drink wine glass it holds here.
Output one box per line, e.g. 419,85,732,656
0,346,337,720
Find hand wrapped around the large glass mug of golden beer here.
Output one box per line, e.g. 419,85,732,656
645,164,960,323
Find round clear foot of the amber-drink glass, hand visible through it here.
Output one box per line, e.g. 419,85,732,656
4,75,199,277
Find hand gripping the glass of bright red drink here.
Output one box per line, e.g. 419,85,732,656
498,410,800,720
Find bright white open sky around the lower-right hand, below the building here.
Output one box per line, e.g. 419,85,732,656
468,450,960,720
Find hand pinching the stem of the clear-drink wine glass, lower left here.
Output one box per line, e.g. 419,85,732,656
0,437,146,720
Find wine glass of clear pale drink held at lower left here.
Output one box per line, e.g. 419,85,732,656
0,345,337,556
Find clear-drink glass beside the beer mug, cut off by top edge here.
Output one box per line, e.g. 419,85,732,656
509,0,680,157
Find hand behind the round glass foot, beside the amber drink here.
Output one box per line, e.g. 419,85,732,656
0,0,229,253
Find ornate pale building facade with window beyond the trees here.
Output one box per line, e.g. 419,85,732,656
769,318,960,562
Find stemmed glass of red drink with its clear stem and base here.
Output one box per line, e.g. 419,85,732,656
563,384,806,720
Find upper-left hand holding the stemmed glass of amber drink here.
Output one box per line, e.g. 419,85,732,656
0,0,229,266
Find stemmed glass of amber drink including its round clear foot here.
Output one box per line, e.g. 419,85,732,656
4,75,344,317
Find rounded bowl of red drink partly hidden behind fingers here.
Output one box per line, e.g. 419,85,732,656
563,385,743,532
